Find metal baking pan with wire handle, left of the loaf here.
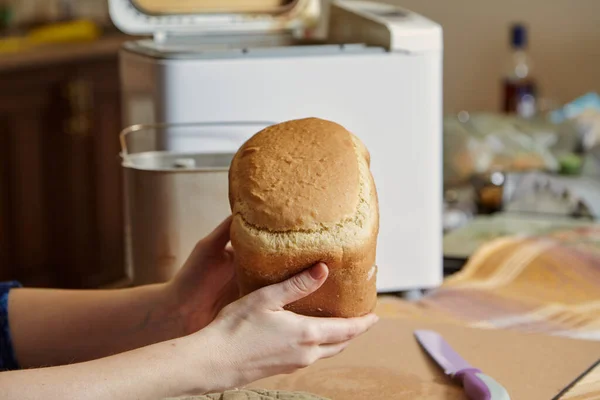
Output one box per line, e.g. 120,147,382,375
121,122,271,285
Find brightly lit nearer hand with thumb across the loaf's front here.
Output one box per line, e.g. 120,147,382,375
188,264,378,390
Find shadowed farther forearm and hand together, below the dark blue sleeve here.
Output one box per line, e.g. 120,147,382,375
8,218,238,368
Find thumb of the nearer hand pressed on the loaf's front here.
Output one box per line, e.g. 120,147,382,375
257,263,329,311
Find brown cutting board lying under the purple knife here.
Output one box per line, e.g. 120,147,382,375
250,319,600,400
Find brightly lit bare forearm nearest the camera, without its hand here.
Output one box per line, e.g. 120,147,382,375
0,337,219,400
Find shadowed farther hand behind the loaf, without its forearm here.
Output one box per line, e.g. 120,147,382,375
167,217,239,335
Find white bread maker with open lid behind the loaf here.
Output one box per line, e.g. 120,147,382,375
109,0,443,292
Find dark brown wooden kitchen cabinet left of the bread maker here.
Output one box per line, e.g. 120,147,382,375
0,40,125,288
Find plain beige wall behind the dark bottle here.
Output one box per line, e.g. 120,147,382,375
388,0,600,113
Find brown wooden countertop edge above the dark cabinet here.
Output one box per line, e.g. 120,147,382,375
0,34,143,72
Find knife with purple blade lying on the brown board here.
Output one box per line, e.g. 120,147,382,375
415,330,510,400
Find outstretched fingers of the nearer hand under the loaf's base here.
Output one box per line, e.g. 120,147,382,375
302,314,379,344
